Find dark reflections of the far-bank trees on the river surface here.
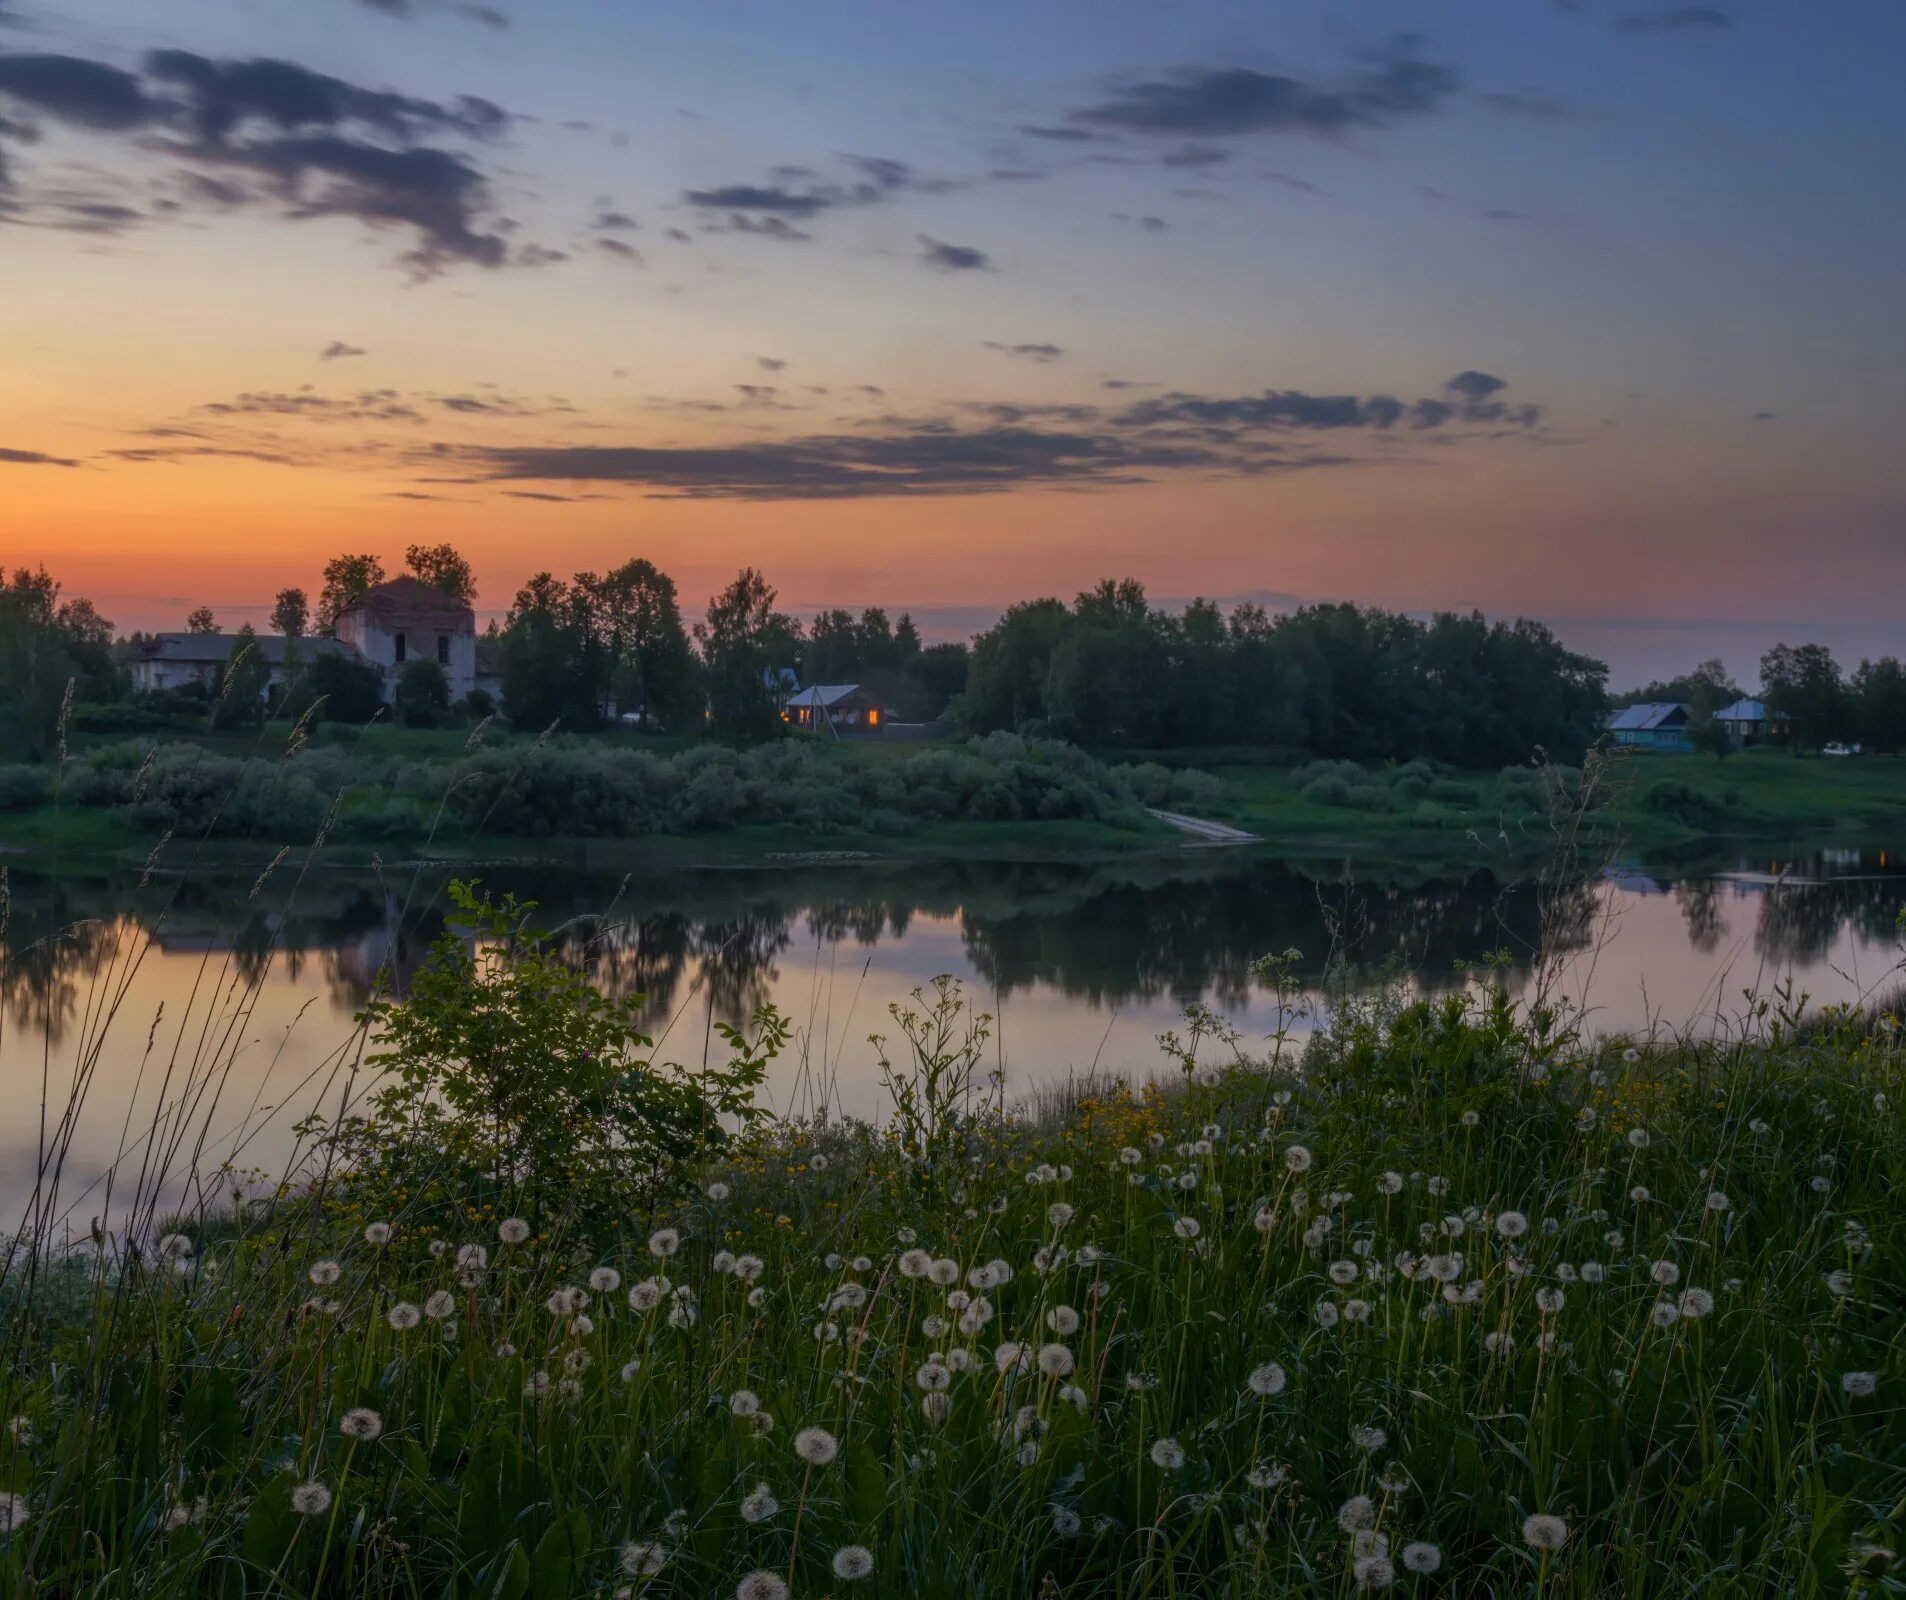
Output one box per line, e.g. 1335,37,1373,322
0,852,1906,1043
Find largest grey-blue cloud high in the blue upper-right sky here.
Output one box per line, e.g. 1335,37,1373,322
1067,40,1458,139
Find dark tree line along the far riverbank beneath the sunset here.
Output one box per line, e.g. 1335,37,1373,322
0,544,1906,769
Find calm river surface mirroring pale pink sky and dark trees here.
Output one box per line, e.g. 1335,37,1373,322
0,860,1906,1232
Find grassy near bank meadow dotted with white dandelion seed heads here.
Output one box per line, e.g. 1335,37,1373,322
0,988,1906,1600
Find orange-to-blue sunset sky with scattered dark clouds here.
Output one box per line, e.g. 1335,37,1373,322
0,0,1906,683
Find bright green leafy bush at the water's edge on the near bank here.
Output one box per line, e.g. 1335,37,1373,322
345,883,773,1228
